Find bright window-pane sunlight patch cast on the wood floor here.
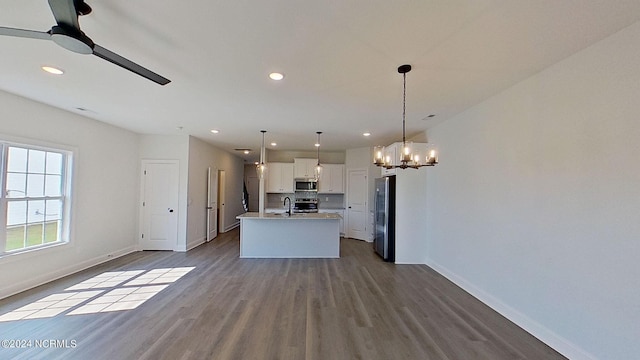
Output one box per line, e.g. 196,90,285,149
0,267,195,322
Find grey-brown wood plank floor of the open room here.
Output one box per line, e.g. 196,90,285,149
0,229,564,360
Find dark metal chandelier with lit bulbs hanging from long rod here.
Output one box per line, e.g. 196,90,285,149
373,65,438,169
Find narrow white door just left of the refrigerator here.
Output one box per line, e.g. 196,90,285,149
347,170,369,240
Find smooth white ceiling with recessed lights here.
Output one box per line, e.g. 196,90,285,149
0,0,640,160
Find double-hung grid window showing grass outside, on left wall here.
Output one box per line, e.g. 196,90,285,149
0,143,71,256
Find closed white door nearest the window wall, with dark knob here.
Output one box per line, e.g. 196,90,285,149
140,160,179,250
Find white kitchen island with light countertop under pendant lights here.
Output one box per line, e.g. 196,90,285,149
237,212,341,258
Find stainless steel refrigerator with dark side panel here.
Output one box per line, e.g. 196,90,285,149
373,176,396,262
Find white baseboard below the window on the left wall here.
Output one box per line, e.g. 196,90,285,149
0,245,137,299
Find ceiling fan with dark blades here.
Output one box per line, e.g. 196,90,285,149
0,0,171,85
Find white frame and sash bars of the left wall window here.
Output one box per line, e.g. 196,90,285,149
0,138,74,258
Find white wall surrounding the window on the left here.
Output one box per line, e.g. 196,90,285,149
0,91,138,298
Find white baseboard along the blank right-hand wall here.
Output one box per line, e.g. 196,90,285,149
426,259,596,360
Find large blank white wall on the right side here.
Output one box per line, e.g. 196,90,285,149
426,23,640,359
